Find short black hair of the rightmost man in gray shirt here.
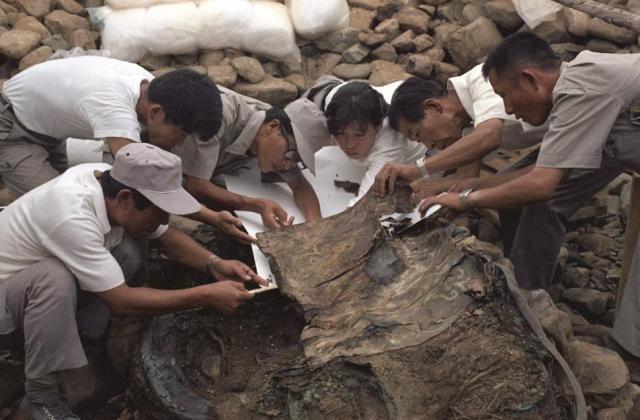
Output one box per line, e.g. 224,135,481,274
482,32,562,79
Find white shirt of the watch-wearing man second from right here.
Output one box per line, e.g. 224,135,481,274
449,64,548,150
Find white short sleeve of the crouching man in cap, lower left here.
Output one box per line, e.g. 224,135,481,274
43,216,124,292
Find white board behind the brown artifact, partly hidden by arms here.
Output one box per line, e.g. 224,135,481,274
224,146,367,288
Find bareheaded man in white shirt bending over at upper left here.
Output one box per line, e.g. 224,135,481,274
0,56,222,196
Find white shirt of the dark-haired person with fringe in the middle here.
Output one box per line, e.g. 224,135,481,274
325,81,427,206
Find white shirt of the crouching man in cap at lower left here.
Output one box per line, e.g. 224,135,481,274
0,163,168,292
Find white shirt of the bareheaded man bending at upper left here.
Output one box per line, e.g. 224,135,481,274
2,56,153,141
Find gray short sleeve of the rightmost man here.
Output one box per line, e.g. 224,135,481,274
536,89,622,169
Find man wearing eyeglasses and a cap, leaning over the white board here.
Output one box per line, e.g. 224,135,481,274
173,87,330,236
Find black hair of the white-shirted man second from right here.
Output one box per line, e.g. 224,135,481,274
389,77,444,131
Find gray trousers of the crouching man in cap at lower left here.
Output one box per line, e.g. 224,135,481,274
0,236,142,379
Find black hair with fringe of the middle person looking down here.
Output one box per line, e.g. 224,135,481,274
325,82,389,136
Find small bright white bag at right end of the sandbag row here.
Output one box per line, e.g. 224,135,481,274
286,0,349,39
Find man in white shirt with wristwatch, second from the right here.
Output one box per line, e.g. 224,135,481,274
375,65,545,195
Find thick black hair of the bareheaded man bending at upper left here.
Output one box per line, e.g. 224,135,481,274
147,69,222,141
